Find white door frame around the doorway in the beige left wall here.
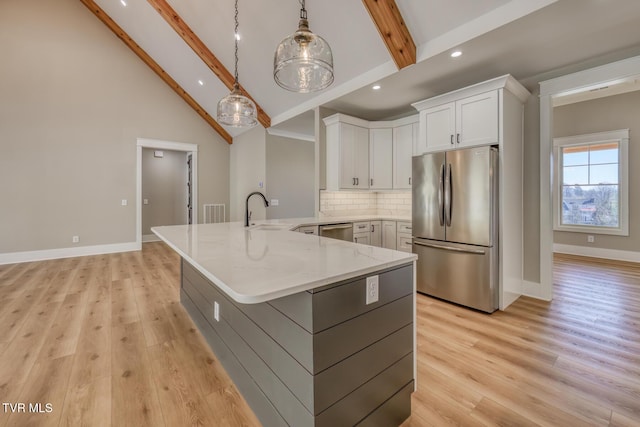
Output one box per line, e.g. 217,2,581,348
136,138,198,250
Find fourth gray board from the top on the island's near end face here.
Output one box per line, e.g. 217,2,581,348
316,353,413,427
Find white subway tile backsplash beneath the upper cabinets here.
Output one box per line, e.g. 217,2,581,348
320,190,411,217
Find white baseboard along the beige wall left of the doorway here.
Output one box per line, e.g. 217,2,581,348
0,242,140,265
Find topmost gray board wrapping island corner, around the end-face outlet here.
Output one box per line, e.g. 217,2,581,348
269,264,413,333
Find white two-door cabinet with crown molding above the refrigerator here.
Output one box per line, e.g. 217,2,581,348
412,75,529,155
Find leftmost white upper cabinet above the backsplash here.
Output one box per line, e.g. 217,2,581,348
324,114,369,190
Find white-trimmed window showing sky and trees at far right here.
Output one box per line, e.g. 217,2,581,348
553,129,629,236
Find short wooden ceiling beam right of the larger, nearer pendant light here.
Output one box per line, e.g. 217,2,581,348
362,0,416,70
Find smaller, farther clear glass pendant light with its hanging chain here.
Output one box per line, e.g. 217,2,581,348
218,0,258,128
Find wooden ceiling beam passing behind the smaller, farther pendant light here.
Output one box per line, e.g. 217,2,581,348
147,0,271,128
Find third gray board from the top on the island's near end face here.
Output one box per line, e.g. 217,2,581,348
315,325,413,415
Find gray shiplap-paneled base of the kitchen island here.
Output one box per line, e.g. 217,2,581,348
180,259,415,427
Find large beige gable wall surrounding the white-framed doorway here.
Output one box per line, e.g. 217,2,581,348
0,0,229,261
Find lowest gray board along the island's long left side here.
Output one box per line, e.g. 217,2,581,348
180,291,287,427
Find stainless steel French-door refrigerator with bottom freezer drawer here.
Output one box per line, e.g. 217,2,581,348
412,146,499,313
